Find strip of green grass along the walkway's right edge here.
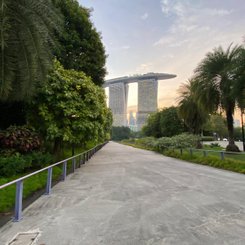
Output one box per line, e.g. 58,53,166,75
122,141,245,174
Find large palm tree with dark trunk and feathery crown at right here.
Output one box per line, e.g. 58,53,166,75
195,45,242,151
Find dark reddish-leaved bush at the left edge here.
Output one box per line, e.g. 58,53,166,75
0,126,41,153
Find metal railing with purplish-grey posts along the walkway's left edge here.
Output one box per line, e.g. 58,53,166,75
0,142,107,222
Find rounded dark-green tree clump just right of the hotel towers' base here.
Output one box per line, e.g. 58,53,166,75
142,106,185,138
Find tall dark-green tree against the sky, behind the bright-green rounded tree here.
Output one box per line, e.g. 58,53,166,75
53,0,106,85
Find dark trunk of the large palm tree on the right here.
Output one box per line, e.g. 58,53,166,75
226,108,240,152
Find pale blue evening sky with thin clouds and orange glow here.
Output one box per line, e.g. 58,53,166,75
79,0,245,109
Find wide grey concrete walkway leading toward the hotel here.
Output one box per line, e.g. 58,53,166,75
0,143,245,245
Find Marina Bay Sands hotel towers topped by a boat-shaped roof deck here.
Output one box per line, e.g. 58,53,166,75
104,73,176,130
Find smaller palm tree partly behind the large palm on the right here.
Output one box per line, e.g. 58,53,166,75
178,79,208,134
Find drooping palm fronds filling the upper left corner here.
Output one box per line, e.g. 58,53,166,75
0,0,60,100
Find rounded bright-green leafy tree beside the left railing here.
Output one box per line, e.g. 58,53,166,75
29,61,112,153
